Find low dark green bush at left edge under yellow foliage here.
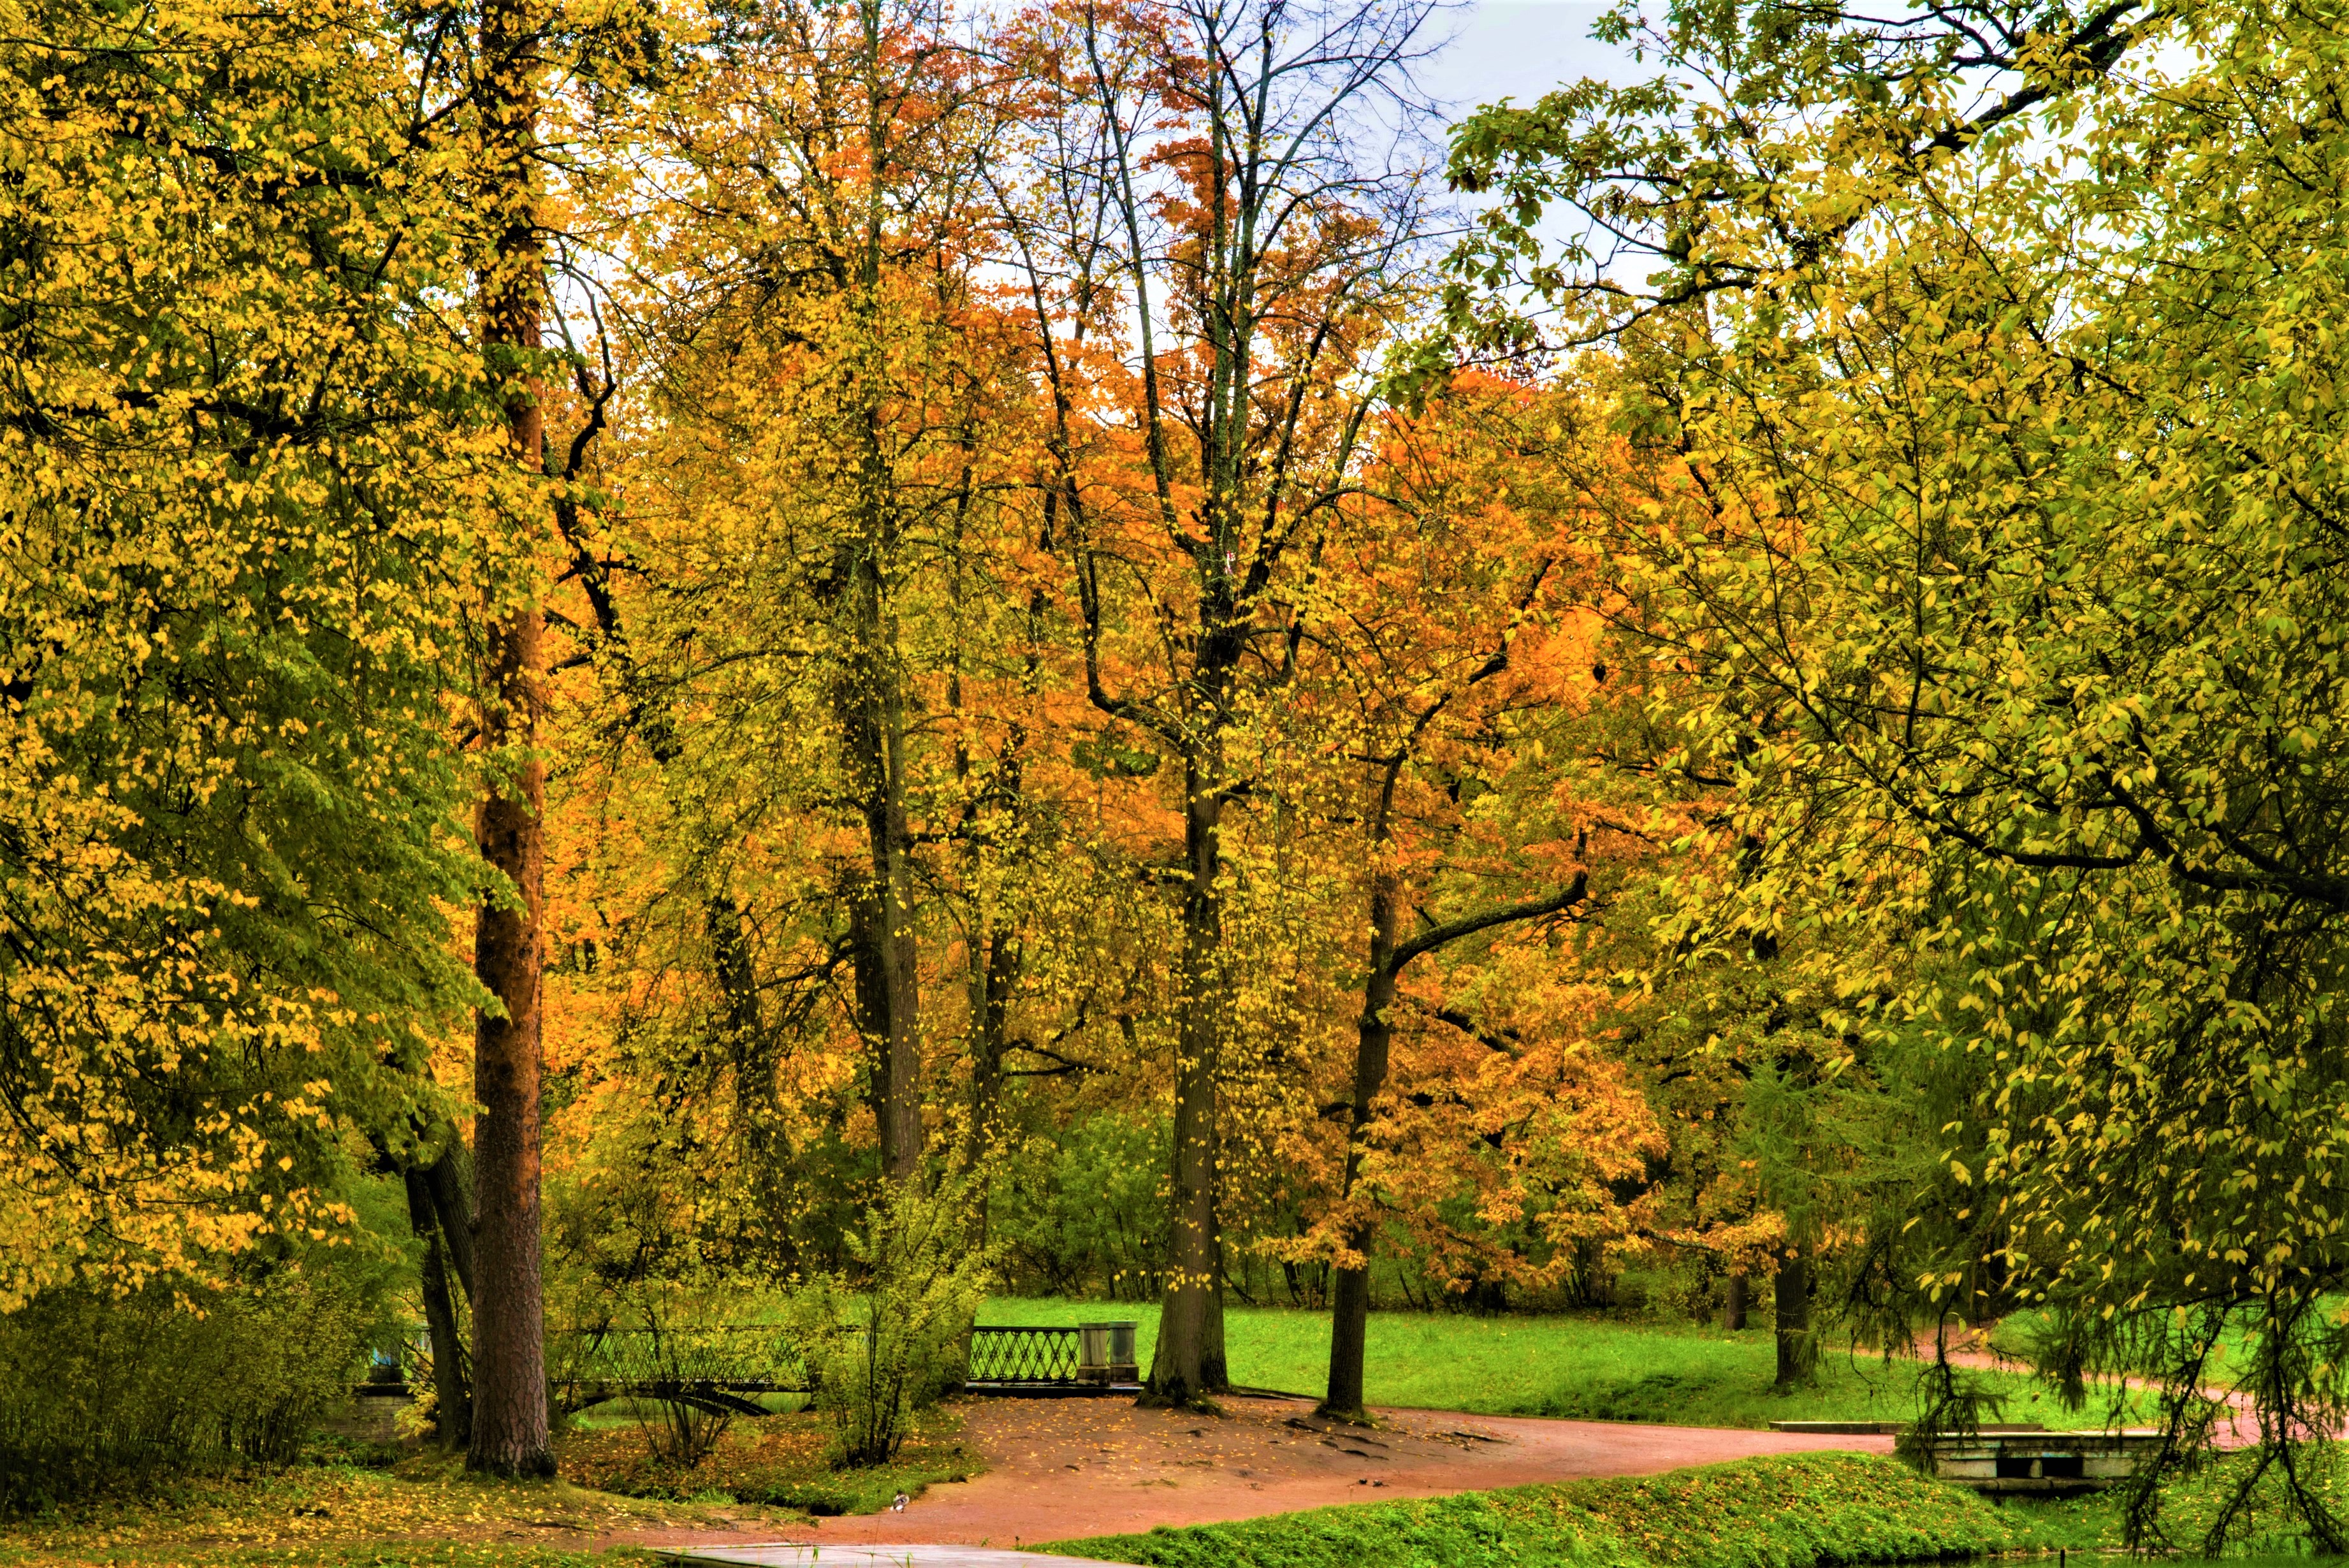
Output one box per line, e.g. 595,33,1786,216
0,1268,383,1509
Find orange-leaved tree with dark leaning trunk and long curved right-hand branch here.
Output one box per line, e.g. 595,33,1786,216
1306,375,1656,1420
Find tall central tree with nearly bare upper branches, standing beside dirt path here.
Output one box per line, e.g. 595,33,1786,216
1024,0,1426,1404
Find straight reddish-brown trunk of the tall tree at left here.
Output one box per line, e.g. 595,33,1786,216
465,0,555,1476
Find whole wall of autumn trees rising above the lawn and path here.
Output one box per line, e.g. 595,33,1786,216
0,0,2349,1550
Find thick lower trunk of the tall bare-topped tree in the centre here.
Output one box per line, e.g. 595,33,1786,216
1144,760,1231,1406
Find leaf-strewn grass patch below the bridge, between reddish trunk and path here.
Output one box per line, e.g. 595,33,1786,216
562,1411,987,1516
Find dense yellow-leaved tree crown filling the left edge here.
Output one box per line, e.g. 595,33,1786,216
0,4,517,1305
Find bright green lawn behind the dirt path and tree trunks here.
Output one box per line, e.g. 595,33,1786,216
980,1298,2095,1427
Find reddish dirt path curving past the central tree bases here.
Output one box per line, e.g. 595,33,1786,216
606,1399,1893,1547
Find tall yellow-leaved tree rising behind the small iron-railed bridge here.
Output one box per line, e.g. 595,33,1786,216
564,4,1024,1223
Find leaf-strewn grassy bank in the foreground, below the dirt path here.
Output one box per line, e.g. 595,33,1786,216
1038,1453,2100,1568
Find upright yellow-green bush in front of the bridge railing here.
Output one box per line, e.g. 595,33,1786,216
794,1183,987,1467
